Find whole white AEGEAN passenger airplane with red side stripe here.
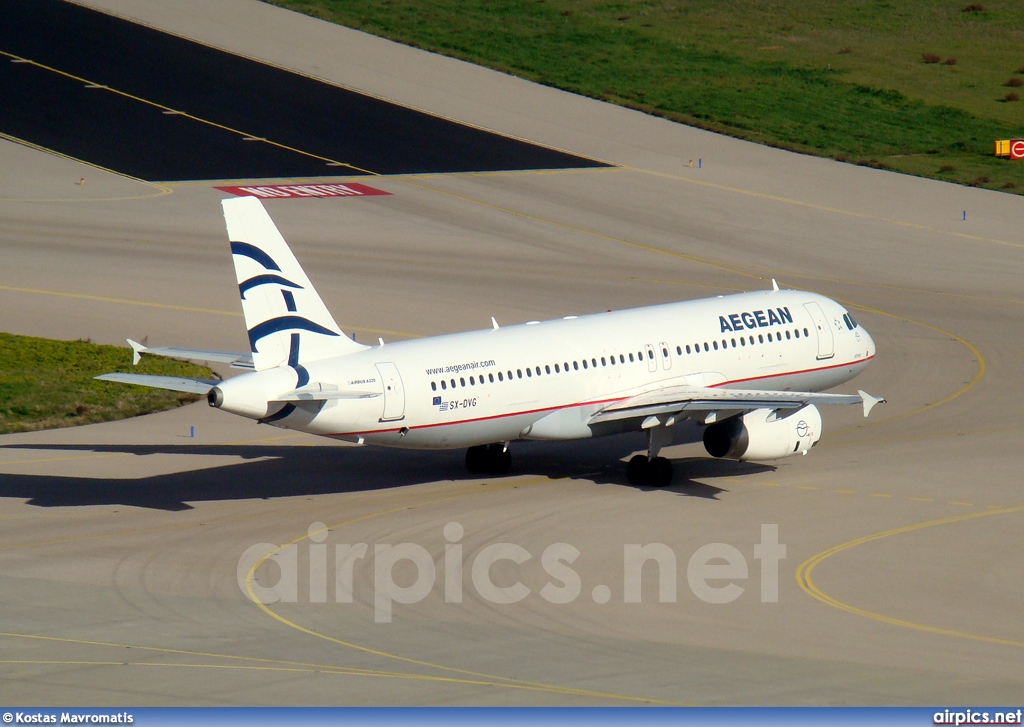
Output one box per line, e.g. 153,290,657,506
97,197,884,486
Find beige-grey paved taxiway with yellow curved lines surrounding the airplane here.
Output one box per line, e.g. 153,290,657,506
0,0,1024,707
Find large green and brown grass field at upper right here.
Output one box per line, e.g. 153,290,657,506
270,0,1024,193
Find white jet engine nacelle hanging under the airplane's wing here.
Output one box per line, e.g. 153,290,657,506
703,404,821,462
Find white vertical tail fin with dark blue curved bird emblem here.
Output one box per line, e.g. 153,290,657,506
221,197,367,372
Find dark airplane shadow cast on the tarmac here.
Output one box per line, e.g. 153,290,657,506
0,435,774,511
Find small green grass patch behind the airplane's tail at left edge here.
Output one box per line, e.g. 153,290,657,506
0,333,212,434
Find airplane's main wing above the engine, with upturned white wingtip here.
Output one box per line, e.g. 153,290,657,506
590,386,885,424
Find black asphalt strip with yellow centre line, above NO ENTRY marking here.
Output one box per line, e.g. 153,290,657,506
0,0,605,181
